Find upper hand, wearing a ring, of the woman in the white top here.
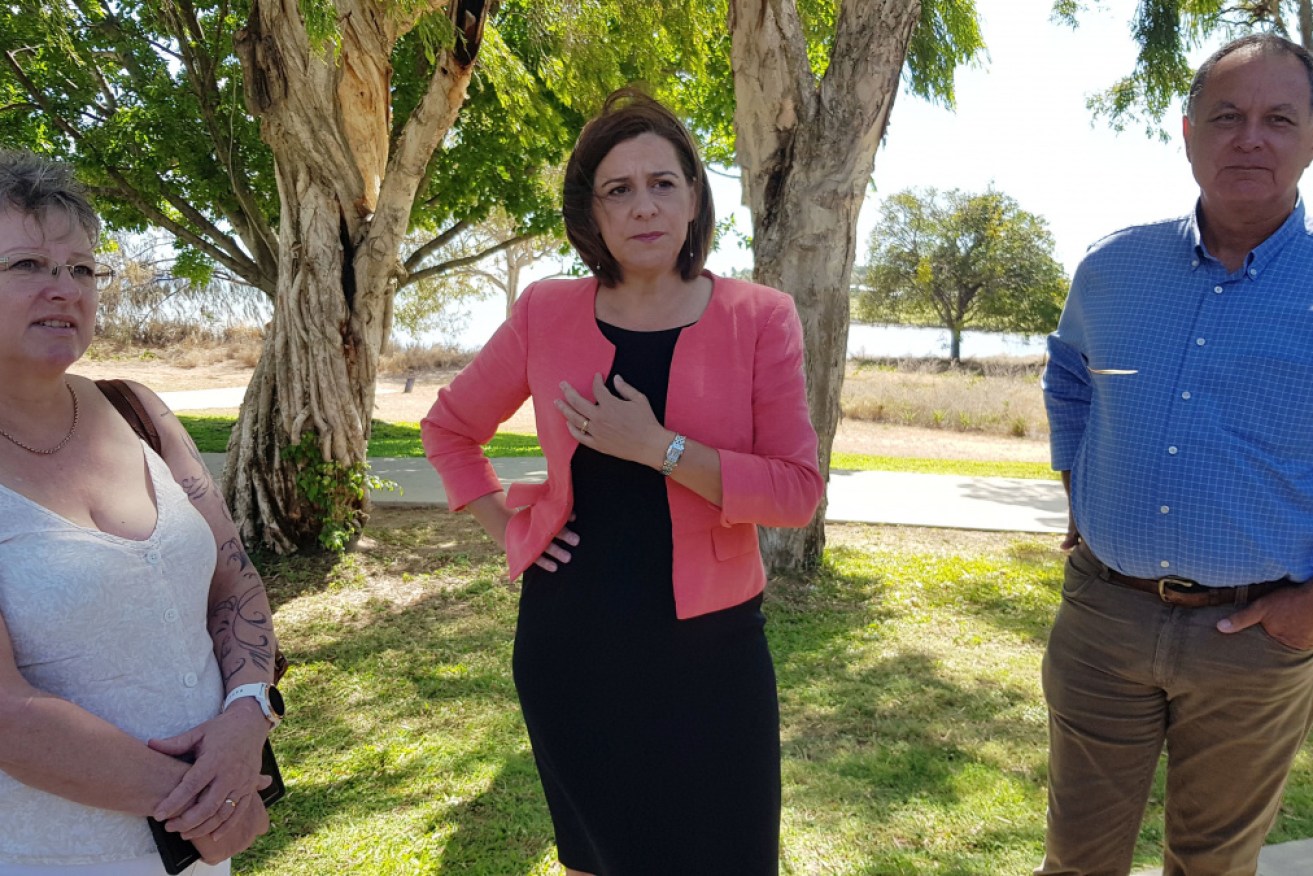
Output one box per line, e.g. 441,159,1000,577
148,697,270,839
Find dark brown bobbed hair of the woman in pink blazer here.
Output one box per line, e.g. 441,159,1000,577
561,87,716,286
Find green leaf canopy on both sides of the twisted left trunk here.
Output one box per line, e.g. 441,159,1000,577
0,0,733,297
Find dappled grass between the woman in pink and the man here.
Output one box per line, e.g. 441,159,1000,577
769,551,1048,876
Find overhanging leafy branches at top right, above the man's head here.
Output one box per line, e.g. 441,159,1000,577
1053,0,1313,141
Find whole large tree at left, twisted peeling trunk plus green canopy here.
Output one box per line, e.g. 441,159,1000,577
0,0,723,552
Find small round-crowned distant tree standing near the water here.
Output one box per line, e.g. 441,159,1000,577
853,188,1066,362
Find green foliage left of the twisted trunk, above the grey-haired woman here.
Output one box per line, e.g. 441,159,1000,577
0,0,278,261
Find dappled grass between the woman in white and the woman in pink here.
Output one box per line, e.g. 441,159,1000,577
242,514,553,876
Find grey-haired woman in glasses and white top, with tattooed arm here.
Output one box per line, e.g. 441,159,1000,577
0,151,281,876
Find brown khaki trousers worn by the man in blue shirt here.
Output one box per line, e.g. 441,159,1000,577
1035,545,1313,876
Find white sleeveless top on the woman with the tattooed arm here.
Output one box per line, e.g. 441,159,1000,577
0,443,223,872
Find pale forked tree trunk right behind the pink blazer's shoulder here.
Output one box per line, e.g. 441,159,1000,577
730,0,920,571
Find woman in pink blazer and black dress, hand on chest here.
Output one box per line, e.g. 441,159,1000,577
423,89,825,876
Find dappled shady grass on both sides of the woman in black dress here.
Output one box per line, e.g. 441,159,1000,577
243,511,1048,876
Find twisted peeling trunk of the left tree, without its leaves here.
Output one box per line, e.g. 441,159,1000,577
225,0,488,553
